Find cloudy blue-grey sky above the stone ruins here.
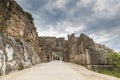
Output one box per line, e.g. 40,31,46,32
16,0,120,52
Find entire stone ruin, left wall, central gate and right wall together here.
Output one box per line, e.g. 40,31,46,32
0,0,111,75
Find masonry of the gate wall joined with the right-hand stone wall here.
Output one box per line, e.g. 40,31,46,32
39,34,112,71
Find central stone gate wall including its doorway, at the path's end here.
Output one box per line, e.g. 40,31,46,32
39,37,69,61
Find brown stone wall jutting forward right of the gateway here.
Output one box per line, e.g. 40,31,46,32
68,34,112,70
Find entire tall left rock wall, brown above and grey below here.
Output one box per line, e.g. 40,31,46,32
0,0,41,75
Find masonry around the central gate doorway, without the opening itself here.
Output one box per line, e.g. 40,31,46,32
39,37,66,62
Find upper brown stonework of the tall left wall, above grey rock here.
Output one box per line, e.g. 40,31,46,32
0,0,41,57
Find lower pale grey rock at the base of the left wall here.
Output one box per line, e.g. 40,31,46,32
0,34,40,75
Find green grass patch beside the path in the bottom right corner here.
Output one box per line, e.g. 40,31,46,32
100,69,120,78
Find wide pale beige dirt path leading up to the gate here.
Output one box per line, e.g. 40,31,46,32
0,61,120,80
